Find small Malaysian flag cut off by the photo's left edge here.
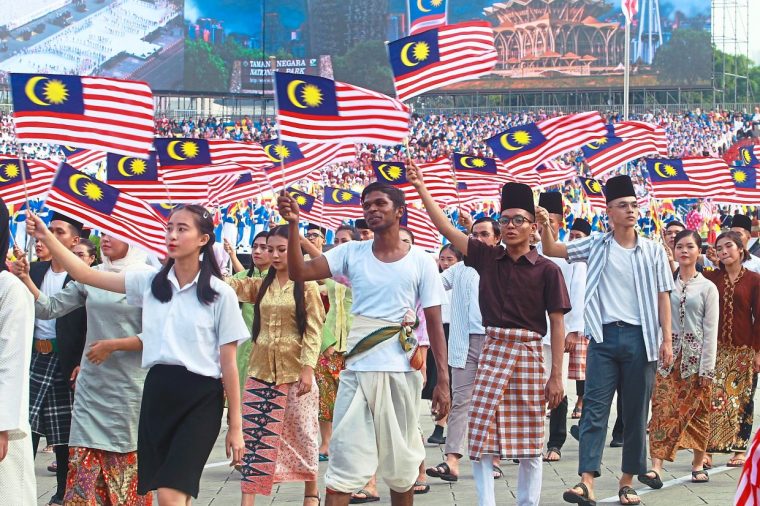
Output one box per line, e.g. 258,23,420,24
0,158,58,206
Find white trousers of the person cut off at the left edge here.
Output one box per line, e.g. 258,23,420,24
0,431,37,506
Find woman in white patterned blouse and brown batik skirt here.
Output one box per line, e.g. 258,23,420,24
639,230,720,489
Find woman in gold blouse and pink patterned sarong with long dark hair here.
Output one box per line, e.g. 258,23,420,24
227,225,325,506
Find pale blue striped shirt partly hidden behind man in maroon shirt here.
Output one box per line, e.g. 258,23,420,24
441,262,486,369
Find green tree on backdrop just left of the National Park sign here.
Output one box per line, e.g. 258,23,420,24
185,39,231,92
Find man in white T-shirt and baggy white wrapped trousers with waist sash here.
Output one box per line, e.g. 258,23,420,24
278,183,449,506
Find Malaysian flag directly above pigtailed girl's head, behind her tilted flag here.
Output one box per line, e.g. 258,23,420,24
106,151,209,204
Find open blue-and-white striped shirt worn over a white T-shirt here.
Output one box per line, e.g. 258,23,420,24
567,232,673,362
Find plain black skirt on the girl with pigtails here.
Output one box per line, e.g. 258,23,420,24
137,365,224,498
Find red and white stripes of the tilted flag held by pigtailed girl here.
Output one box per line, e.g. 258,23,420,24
45,181,167,257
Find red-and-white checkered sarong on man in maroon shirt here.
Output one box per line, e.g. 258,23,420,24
468,327,546,460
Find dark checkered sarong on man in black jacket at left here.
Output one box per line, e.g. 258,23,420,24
29,351,74,445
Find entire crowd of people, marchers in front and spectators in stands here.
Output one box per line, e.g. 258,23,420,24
0,104,760,506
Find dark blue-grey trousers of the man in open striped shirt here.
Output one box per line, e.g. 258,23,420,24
578,323,657,476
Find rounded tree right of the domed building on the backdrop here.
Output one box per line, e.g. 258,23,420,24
653,30,713,84
